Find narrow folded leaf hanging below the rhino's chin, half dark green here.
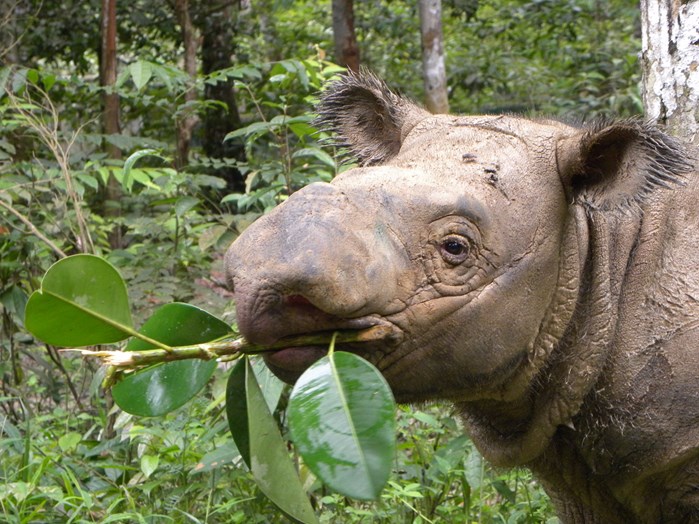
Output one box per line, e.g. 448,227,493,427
226,358,318,523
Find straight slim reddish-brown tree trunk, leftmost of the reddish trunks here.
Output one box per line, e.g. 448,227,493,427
100,0,122,248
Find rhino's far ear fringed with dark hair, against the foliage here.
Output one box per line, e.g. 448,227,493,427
316,70,429,165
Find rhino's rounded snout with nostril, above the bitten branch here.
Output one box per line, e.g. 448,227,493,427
225,184,404,350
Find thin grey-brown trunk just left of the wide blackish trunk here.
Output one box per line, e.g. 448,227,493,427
175,0,198,170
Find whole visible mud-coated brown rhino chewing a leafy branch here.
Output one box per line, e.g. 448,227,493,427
225,73,699,524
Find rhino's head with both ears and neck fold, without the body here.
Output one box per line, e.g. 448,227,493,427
225,73,686,465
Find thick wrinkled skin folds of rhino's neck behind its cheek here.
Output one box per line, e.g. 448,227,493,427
458,205,632,466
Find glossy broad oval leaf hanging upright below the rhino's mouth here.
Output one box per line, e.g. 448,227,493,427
287,352,395,500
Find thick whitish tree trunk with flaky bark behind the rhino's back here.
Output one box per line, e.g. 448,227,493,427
641,0,699,146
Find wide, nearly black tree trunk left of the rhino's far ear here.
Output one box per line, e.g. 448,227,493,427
199,2,245,193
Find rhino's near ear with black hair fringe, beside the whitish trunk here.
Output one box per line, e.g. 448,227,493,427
556,119,692,209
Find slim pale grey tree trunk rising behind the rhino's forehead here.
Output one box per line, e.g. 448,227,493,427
419,0,449,113
